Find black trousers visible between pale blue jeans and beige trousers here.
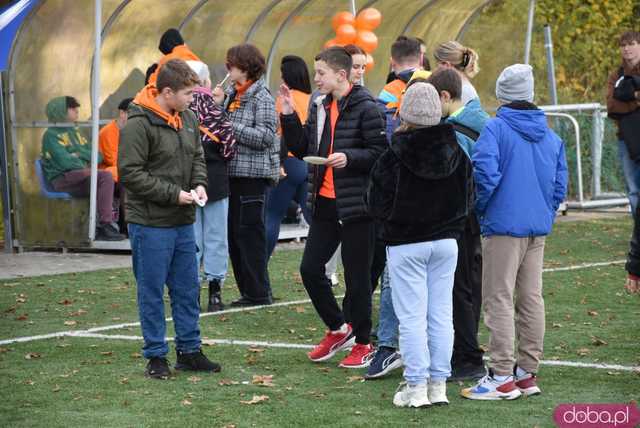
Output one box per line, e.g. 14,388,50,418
451,213,484,367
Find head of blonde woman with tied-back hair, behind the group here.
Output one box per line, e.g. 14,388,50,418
433,40,480,104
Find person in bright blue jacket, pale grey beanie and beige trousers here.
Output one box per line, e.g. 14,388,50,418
462,64,568,400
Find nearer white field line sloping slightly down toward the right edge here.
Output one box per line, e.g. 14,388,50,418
66,333,640,372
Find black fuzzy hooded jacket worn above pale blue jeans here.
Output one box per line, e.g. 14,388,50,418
366,124,473,245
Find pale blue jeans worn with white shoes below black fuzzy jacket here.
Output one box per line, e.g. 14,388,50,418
387,239,458,385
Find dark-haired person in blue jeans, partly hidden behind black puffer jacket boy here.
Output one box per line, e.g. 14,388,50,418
267,55,311,257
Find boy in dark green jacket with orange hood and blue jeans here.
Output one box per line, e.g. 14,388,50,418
118,60,220,379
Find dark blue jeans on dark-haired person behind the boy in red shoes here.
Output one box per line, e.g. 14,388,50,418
267,157,311,257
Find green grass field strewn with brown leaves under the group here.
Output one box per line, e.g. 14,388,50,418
0,217,640,427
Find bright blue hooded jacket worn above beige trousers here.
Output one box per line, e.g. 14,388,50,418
472,103,568,237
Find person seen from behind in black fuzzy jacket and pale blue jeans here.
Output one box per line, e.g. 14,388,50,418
367,82,471,407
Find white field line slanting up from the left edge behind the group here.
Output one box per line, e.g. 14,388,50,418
0,260,625,345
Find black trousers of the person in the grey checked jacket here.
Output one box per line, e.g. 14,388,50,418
228,177,271,303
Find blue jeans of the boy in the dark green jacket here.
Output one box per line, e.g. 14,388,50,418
129,223,200,358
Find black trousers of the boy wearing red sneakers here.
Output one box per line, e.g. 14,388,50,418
300,196,375,344
